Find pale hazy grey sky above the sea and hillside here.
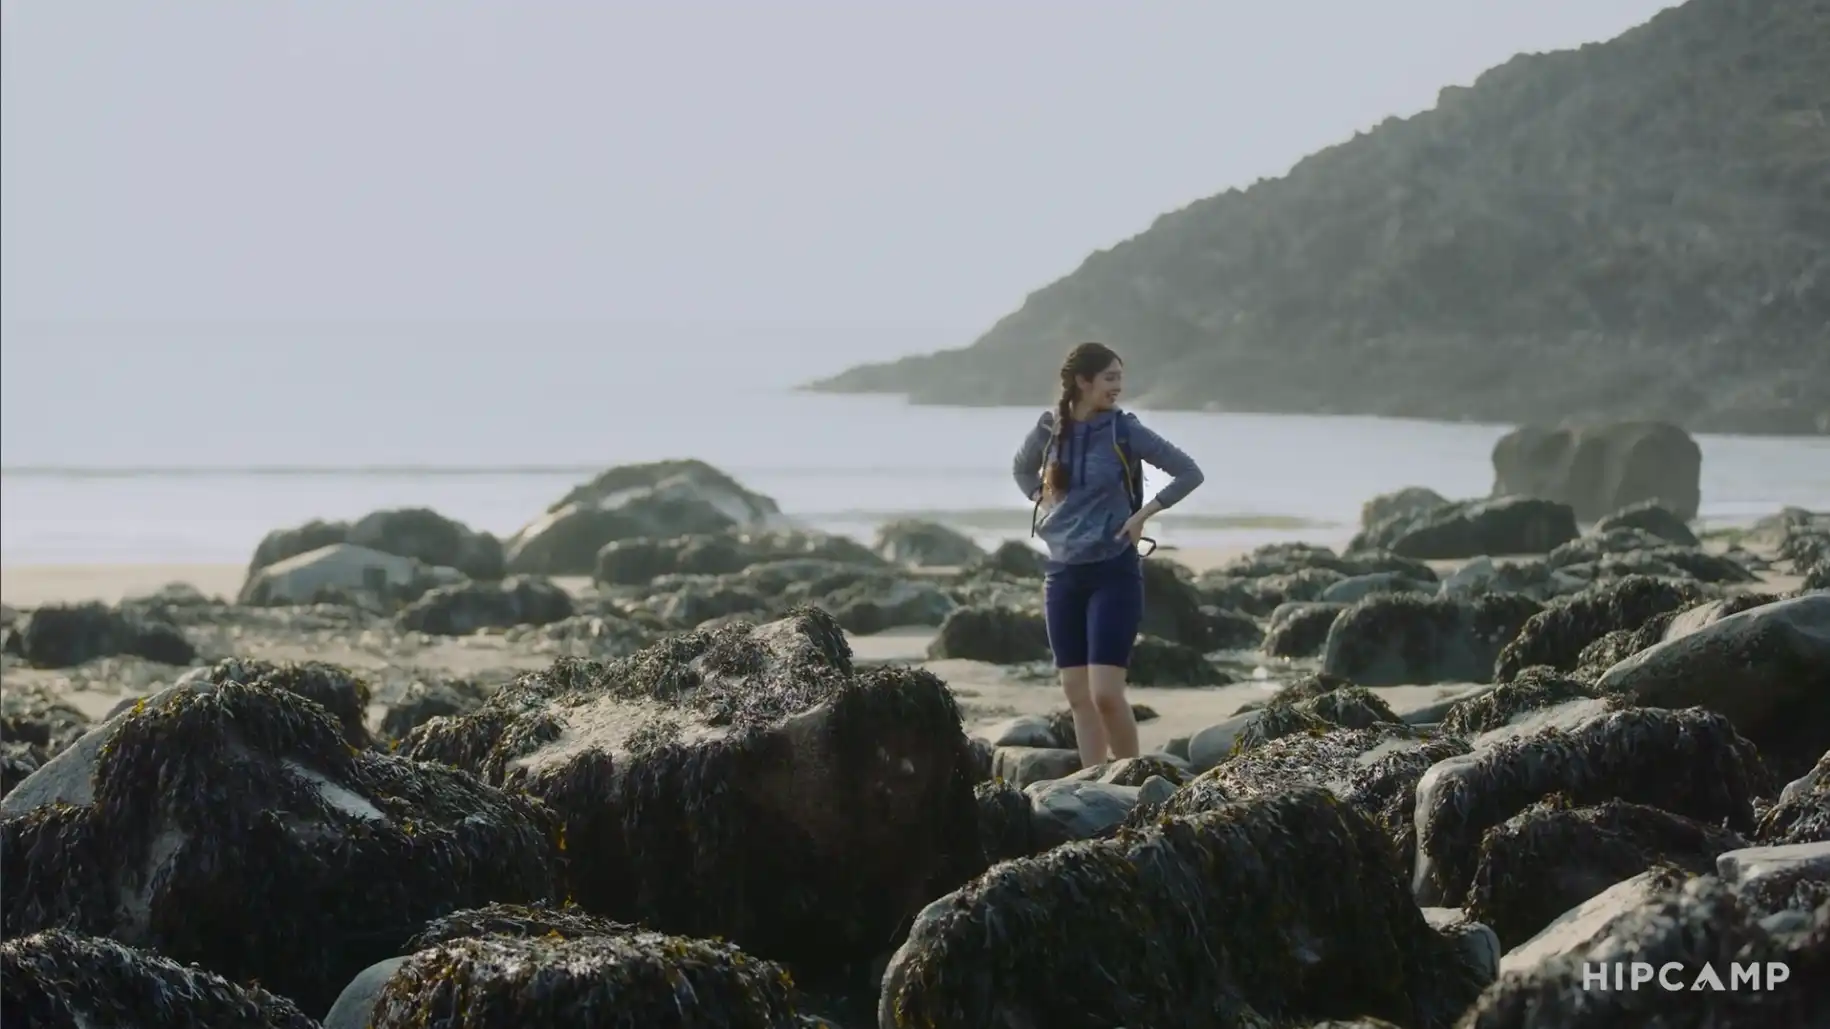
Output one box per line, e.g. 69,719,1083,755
0,0,1667,344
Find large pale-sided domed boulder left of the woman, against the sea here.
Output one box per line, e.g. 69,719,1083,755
503,460,781,575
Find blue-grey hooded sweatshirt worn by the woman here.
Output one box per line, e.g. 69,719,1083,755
1010,410,1202,571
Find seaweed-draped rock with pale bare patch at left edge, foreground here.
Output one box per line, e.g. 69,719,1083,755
0,683,560,1011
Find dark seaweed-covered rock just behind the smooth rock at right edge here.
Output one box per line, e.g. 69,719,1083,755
1493,575,1707,683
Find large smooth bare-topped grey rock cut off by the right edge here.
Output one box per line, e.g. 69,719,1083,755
1596,593,1830,776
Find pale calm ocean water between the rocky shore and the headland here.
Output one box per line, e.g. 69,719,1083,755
0,324,1830,566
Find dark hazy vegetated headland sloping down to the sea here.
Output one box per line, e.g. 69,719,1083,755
813,0,1830,432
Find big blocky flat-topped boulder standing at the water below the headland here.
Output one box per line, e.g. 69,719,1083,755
1493,421,1704,522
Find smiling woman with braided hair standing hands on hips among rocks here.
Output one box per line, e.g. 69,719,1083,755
1012,342,1202,767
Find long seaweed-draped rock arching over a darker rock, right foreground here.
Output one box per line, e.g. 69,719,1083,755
1413,709,1768,904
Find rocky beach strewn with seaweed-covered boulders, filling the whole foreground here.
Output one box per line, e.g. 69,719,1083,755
0,461,1830,1029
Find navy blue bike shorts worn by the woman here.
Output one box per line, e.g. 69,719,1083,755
1043,547,1144,668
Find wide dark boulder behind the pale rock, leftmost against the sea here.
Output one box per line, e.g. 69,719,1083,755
247,507,501,579
